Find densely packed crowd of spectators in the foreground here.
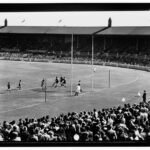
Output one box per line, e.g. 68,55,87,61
0,102,150,142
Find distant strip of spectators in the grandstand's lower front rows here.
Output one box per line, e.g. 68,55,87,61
0,52,150,67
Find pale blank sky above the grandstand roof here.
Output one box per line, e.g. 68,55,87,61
0,11,150,26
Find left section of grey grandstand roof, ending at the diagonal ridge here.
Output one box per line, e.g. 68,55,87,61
0,26,103,34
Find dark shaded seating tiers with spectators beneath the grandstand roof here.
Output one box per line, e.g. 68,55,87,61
0,35,150,66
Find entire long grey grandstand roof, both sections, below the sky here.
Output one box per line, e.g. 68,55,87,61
0,26,150,35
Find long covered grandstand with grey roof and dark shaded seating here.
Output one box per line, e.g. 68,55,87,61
0,26,150,66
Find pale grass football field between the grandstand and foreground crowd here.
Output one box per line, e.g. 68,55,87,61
0,60,150,122
